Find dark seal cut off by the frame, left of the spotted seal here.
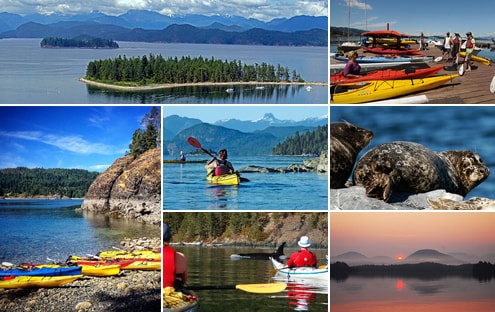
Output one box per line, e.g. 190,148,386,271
330,122,373,188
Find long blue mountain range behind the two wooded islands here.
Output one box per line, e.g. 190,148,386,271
0,10,328,46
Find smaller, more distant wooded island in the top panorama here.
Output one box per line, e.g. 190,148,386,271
40,36,119,49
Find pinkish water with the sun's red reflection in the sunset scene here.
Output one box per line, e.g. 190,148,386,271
330,277,495,312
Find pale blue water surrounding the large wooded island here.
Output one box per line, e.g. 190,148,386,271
0,39,328,104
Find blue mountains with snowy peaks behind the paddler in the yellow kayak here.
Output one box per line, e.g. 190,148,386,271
163,113,328,156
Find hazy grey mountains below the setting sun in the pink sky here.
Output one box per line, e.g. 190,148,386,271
331,249,495,266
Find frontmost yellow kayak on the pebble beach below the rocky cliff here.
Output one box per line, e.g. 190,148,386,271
0,275,82,288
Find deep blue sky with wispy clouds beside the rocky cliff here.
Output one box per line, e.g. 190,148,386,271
0,106,157,171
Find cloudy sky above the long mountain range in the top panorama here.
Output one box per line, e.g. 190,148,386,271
0,0,328,21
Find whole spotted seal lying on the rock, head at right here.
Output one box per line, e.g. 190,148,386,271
353,142,490,201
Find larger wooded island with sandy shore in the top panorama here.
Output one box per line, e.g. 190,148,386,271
85,54,304,86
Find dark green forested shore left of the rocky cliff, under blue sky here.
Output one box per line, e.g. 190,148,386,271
0,167,98,198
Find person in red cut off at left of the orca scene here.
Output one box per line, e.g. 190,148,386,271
162,223,187,289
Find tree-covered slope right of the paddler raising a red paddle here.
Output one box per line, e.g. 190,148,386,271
272,125,328,155
